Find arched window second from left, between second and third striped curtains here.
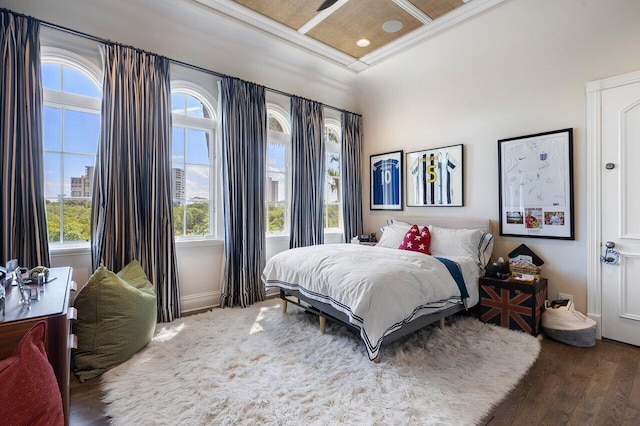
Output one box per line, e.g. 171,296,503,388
171,82,218,237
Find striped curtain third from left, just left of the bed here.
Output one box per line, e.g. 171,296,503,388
219,78,267,307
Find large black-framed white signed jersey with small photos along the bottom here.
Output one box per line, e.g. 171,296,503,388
498,129,575,240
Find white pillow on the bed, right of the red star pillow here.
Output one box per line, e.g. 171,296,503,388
429,225,493,267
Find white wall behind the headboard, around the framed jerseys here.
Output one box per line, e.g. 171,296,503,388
360,0,640,312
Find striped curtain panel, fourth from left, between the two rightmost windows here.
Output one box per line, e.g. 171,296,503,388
289,96,324,248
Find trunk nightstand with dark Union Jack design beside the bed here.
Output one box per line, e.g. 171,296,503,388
479,277,547,336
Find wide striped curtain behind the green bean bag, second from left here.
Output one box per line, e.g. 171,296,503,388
91,45,180,322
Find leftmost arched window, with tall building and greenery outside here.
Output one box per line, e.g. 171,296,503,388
42,50,102,243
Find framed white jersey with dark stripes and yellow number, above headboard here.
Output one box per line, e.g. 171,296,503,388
405,144,464,207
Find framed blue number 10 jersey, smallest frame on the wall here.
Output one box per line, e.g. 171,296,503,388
369,151,403,210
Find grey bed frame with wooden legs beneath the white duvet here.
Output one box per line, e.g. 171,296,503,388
280,289,465,363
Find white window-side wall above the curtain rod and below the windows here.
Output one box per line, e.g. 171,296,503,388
0,0,360,312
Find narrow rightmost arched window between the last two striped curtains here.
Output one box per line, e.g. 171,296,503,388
324,119,342,232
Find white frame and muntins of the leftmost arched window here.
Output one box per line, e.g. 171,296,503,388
40,46,102,251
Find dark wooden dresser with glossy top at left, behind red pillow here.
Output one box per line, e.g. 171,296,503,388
0,267,76,424
